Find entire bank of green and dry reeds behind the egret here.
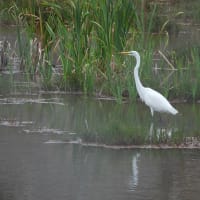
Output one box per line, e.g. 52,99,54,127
2,0,200,102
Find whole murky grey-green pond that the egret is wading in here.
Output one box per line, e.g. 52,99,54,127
0,1,200,200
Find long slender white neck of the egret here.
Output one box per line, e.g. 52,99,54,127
134,54,144,100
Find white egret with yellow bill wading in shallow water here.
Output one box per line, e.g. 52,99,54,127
121,51,178,116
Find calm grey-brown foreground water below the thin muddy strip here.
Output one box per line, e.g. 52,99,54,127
0,130,200,200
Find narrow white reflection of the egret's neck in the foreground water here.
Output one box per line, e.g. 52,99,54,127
129,153,140,191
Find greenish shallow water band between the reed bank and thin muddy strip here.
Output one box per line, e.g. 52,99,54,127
0,86,200,148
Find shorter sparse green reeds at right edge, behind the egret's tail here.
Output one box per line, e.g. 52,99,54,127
165,47,200,102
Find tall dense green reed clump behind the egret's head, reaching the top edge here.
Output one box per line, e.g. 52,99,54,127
7,0,166,102
